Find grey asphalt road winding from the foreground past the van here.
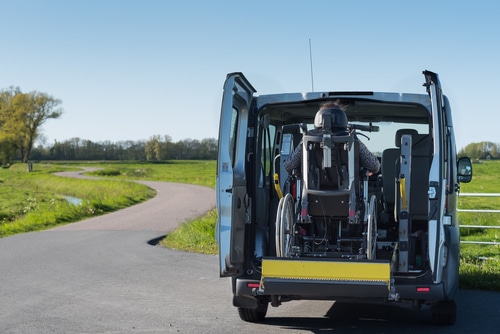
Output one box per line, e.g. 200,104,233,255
0,171,500,334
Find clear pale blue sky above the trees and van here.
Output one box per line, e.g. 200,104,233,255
0,0,500,149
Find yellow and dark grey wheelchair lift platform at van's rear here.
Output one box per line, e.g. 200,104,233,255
261,259,391,298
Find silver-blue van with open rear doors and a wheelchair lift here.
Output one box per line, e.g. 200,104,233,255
216,70,472,325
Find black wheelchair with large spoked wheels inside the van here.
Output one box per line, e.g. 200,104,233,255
275,128,377,260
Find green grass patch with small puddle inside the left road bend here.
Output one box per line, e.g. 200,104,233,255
0,164,155,237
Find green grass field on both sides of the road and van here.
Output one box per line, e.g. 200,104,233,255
0,161,500,291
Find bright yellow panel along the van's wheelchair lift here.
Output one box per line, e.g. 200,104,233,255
262,259,391,284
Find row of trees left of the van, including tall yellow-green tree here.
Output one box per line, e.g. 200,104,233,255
0,87,217,165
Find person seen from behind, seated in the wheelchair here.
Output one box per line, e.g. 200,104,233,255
284,102,380,176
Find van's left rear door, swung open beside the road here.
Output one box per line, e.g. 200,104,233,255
216,73,256,277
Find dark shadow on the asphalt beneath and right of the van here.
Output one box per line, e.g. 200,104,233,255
247,290,500,334
